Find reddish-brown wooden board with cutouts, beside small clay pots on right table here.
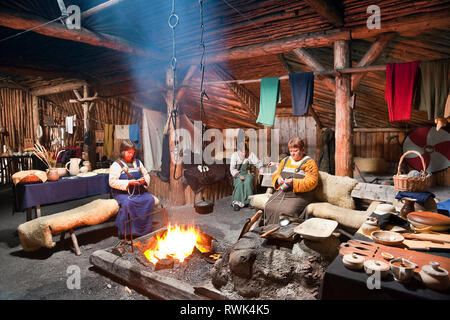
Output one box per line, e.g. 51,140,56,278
339,240,450,272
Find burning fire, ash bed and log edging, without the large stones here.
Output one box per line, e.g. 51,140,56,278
90,225,225,300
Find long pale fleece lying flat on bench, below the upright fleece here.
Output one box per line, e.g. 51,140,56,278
306,202,371,230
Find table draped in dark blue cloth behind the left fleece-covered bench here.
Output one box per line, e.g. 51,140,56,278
14,174,111,221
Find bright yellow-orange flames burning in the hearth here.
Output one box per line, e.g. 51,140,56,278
144,225,207,264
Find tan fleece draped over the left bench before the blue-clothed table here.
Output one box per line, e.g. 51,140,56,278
17,199,119,251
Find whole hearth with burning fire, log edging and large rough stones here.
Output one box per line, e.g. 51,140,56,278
90,208,340,300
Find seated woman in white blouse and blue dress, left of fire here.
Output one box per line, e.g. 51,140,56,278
109,140,155,237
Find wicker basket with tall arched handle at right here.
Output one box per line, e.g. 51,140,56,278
393,150,431,192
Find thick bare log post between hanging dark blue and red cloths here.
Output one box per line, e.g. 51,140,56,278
334,40,353,177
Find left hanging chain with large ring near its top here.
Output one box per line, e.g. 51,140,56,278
167,0,181,180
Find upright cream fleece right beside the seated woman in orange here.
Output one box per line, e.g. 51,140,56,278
315,171,358,209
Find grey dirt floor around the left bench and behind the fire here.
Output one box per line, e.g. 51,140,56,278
0,186,255,300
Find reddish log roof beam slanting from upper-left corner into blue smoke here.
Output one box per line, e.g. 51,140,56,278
0,9,163,59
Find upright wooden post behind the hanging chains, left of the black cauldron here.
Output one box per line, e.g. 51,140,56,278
165,68,185,206
